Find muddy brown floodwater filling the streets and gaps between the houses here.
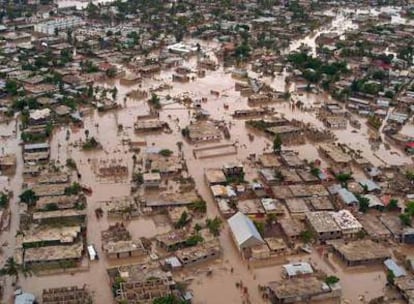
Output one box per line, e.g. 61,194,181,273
0,5,413,304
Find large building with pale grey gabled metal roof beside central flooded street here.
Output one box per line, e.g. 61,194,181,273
228,212,265,250
